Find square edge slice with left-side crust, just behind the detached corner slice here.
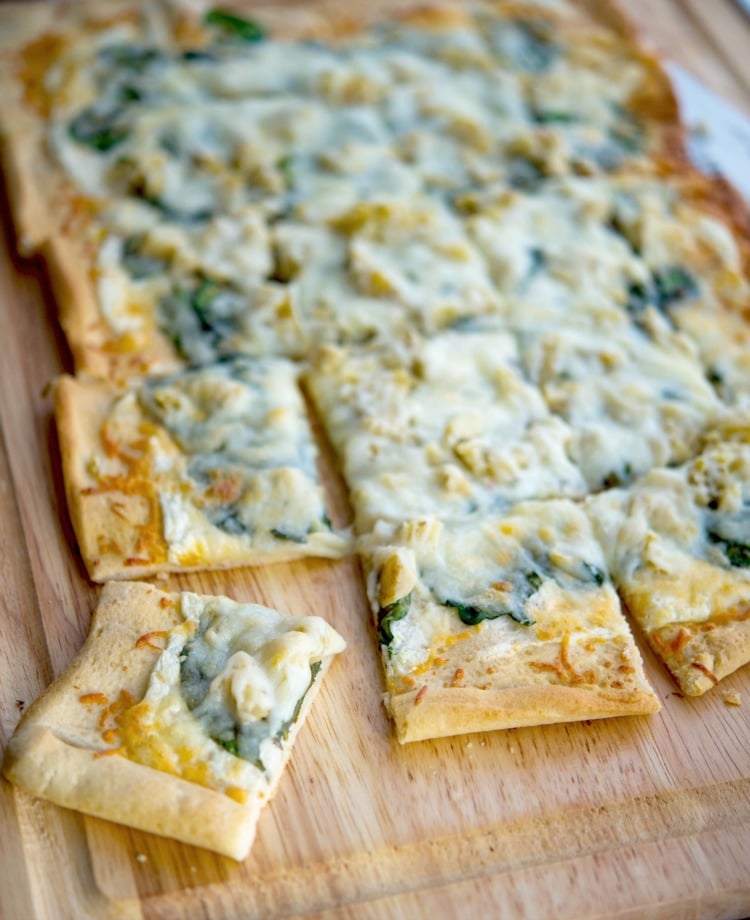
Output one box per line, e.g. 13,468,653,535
56,358,347,581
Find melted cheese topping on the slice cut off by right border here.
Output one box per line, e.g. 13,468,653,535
589,436,750,631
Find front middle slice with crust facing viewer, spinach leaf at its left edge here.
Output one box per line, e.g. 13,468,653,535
360,499,659,743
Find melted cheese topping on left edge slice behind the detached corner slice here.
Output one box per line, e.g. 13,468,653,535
96,359,346,566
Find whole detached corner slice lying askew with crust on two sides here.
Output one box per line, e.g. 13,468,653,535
3,582,345,860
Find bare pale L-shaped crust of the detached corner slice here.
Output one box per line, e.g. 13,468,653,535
3,583,344,860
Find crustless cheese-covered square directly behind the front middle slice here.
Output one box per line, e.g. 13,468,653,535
304,331,586,533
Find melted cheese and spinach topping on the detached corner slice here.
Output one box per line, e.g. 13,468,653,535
119,593,345,798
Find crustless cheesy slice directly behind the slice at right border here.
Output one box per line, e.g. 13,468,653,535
520,326,723,491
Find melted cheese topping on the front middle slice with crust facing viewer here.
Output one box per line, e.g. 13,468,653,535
361,500,632,682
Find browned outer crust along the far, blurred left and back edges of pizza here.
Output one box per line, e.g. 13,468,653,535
0,0,685,380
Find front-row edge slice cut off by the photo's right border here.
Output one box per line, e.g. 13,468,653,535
587,419,750,696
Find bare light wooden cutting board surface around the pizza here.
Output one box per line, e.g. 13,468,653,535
0,0,750,920
